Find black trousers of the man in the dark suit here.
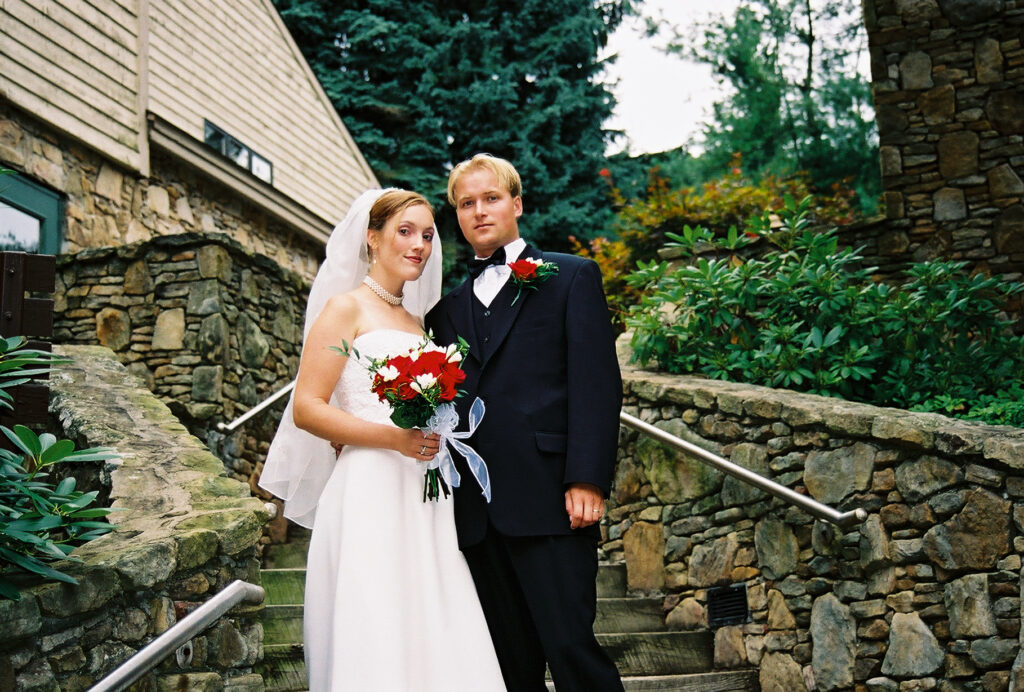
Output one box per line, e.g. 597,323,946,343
463,526,623,692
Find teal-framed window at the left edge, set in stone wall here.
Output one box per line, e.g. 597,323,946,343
0,174,62,255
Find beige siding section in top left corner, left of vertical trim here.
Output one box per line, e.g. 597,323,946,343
0,0,144,170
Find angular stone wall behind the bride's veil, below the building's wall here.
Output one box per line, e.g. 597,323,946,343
54,233,308,513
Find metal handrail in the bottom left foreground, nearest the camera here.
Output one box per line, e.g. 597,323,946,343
89,579,266,692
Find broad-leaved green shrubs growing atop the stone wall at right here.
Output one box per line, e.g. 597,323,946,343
627,194,1024,425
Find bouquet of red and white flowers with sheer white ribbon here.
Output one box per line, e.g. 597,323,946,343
335,335,490,502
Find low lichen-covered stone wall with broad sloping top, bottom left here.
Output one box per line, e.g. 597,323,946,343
0,346,267,692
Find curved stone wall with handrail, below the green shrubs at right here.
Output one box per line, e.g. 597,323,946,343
602,362,1024,692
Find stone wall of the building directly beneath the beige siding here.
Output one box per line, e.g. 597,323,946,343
0,98,324,280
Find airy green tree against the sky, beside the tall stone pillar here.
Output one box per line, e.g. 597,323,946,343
669,0,881,212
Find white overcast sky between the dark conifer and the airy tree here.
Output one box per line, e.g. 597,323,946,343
605,0,737,155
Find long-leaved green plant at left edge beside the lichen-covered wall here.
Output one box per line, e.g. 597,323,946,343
0,337,116,601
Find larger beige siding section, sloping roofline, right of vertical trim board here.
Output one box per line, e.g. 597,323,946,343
148,0,376,221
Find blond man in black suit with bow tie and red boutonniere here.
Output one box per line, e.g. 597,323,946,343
427,154,623,692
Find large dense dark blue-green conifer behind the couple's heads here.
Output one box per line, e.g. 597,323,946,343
274,0,636,249
